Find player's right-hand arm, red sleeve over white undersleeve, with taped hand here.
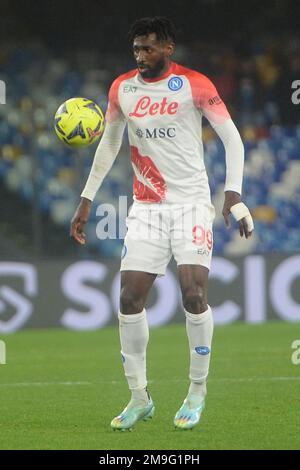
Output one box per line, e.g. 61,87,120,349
201,77,254,238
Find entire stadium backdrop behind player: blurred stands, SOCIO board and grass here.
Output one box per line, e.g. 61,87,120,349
0,0,300,452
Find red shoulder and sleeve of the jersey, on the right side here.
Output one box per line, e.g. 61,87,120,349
173,64,230,124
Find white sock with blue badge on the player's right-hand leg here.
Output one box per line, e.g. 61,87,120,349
185,306,213,406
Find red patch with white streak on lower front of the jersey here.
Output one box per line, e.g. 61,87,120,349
130,146,167,202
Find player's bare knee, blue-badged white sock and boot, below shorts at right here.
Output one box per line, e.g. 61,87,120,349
174,265,213,429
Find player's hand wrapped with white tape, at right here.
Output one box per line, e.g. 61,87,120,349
222,191,254,238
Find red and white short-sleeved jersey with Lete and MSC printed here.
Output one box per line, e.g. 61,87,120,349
106,62,230,203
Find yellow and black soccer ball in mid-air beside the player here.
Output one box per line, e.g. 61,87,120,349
54,98,104,147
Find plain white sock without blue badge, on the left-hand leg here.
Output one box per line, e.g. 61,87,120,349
119,309,149,402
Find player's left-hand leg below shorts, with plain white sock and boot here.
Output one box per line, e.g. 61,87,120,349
111,271,157,430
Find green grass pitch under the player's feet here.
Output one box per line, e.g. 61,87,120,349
0,322,300,450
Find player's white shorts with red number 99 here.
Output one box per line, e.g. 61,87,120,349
120,202,215,276
